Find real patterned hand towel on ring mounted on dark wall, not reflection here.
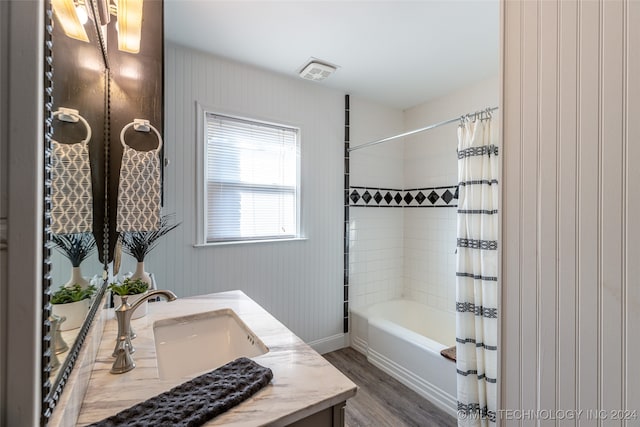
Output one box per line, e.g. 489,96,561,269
116,145,160,231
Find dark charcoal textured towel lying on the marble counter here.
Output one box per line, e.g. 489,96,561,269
91,357,273,427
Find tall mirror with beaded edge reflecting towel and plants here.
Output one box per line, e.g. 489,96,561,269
43,0,108,418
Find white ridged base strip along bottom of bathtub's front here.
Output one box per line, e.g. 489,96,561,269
367,348,458,417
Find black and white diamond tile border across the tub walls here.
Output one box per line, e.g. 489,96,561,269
349,185,458,208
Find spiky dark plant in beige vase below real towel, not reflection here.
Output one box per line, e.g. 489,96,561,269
121,214,180,285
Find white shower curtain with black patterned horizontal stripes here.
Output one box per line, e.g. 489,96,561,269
456,112,499,426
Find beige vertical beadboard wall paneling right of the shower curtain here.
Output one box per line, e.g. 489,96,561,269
501,0,640,426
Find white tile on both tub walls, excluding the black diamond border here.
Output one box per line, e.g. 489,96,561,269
349,76,499,311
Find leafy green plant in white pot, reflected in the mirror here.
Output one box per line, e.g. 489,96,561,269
51,284,96,331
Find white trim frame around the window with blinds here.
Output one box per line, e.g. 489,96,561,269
193,101,307,248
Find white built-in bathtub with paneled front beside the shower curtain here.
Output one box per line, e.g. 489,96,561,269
350,300,457,417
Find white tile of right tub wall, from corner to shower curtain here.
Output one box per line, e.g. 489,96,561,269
403,76,499,311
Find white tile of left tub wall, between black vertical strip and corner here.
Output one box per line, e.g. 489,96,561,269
349,96,404,308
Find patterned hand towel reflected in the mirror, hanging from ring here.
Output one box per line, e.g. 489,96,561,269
51,140,93,234
